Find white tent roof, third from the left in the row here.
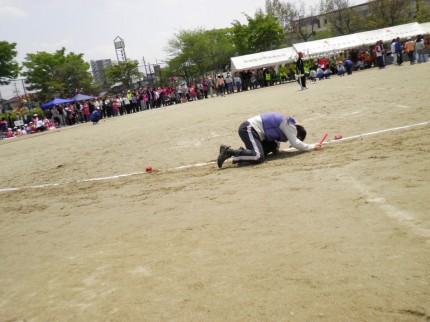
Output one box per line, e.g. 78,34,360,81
356,22,425,45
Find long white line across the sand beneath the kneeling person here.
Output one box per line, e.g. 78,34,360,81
0,121,430,192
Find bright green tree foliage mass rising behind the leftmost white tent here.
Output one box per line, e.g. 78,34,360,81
163,11,284,78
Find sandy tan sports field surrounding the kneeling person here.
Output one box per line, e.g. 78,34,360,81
0,63,430,322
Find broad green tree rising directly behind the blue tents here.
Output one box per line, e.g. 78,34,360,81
23,47,92,101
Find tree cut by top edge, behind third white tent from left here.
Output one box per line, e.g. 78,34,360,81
367,0,416,29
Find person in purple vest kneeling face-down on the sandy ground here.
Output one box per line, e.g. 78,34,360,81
218,113,321,168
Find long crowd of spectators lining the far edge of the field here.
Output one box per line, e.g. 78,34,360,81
0,35,428,138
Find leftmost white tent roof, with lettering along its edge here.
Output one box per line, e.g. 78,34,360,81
231,47,297,71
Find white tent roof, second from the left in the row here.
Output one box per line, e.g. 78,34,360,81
293,34,363,57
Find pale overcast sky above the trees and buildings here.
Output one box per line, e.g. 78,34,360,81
0,0,363,99
